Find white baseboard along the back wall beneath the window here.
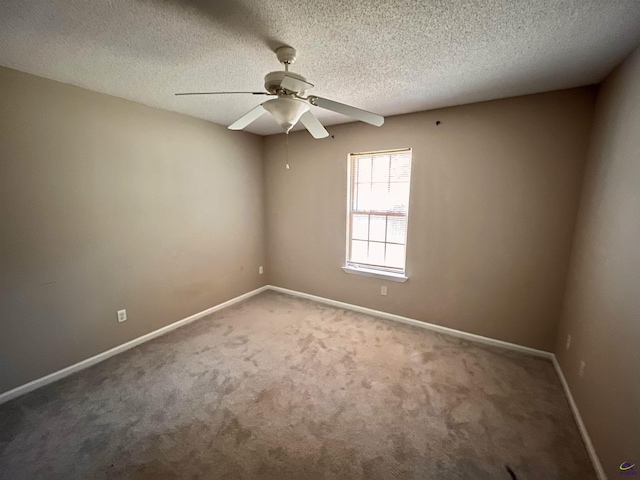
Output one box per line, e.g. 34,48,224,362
267,285,554,360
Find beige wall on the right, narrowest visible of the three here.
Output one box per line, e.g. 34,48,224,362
556,49,640,478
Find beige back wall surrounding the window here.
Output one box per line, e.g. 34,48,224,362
265,88,596,351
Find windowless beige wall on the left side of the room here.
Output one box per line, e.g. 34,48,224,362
0,68,265,398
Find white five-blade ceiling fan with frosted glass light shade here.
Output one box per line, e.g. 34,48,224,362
176,46,384,138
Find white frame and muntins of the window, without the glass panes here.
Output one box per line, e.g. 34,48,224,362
342,148,413,282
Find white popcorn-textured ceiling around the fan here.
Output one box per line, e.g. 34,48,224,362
0,0,640,134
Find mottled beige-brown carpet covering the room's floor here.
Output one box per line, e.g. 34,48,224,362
0,292,596,480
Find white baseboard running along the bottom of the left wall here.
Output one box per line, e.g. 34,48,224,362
0,285,269,404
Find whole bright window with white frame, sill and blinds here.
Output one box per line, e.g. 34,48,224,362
344,149,411,281
